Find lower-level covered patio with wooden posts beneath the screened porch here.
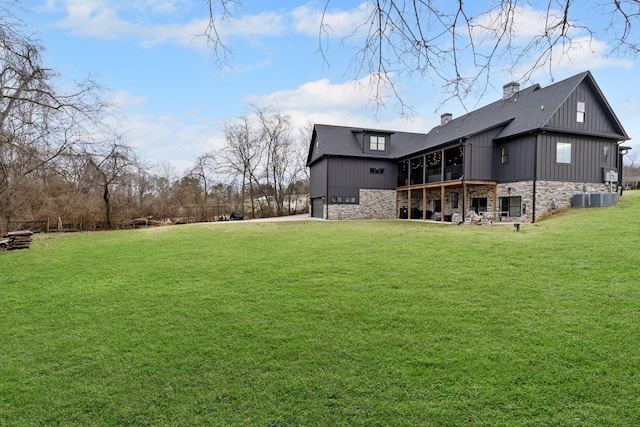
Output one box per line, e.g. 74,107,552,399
396,179,497,222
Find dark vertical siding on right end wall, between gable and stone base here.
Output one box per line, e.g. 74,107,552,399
538,132,617,182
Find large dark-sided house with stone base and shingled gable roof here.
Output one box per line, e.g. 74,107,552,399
307,71,629,223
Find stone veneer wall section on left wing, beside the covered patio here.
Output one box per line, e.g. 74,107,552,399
325,190,396,219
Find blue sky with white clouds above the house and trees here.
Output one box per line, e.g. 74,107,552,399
16,0,640,174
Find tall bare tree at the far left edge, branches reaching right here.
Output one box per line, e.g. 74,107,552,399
0,7,108,224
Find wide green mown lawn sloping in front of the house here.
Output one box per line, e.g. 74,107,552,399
0,192,640,426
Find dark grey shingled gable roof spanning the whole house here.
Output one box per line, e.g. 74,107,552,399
307,71,630,165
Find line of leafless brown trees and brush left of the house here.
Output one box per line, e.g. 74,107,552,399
0,11,309,232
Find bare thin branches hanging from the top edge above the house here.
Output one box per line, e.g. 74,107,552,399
206,0,640,108
